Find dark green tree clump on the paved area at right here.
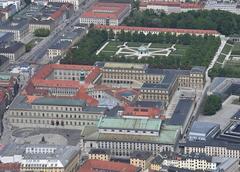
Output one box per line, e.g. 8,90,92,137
204,95,222,115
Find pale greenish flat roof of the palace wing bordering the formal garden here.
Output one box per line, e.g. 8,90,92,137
104,62,147,70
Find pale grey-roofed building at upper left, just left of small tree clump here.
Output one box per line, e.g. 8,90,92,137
0,19,29,41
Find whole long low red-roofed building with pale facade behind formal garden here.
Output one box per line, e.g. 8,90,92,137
95,25,220,36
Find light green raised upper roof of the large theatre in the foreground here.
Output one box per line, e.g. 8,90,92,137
98,117,162,131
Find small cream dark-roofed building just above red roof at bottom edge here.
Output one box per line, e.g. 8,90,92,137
88,149,111,161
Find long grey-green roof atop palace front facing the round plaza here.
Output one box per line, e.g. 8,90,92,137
32,97,85,107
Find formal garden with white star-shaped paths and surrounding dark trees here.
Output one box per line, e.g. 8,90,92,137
61,29,220,69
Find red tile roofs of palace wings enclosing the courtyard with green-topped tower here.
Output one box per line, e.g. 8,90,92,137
22,64,100,106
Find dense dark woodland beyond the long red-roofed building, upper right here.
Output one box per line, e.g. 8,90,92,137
124,10,240,35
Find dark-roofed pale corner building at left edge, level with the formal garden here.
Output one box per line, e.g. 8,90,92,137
0,42,26,63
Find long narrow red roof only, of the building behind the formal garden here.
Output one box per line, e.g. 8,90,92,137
95,25,219,35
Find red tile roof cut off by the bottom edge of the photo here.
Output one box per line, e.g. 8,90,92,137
79,159,137,172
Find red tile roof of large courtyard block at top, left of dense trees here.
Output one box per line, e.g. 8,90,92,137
81,2,130,19
